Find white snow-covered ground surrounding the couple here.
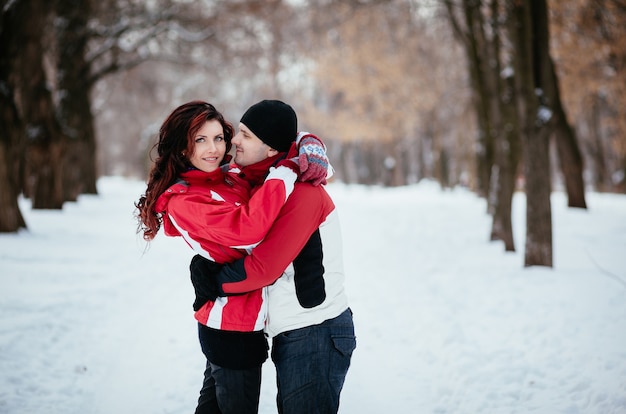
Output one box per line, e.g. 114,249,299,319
0,177,626,414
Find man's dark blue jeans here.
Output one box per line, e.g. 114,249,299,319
272,308,356,414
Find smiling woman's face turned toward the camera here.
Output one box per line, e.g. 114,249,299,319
189,120,226,172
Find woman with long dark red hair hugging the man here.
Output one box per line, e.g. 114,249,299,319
136,101,322,413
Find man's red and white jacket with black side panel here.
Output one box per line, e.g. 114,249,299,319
215,183,348,337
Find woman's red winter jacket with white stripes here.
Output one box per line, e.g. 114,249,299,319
156,159,297,332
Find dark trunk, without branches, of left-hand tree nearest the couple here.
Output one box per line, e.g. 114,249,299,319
56,0,97,201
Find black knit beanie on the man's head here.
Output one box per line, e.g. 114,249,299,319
239,100,298,152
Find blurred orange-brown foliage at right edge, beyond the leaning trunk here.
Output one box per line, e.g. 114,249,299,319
549,0,626,191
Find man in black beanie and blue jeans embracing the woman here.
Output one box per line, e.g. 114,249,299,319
191,101,356,414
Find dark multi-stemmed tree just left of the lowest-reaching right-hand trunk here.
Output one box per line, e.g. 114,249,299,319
445,0,521,251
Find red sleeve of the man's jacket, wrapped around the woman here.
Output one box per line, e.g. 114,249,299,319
222,182,335,294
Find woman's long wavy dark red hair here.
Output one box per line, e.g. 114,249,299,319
135,101,234,241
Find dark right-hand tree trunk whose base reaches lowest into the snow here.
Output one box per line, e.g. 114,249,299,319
509,0,552,267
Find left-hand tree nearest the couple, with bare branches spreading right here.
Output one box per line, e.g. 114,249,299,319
55,0,190,200
